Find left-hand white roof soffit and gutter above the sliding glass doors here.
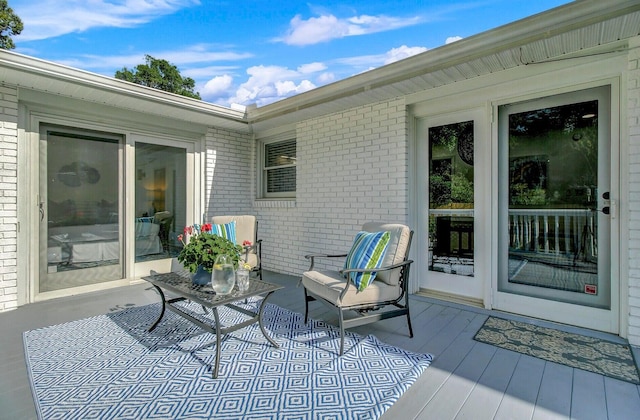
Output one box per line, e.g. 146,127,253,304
0,50,250,132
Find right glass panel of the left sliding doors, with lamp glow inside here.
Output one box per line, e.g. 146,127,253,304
135,142,187,262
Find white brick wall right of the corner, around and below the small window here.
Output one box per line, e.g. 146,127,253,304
252,99,408,274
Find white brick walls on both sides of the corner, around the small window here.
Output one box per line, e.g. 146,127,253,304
205,99,408,275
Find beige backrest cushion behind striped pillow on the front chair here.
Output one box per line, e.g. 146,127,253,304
362,222,411,286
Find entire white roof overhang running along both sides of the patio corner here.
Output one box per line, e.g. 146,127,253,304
0,0,640,132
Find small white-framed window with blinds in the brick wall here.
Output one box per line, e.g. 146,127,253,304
259,138,296,198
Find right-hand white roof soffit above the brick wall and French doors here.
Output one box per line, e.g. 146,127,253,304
247,0,640,131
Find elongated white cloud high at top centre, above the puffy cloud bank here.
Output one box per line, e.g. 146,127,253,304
279,14,421,45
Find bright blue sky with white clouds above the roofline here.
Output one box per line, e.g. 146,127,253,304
9,0,569,106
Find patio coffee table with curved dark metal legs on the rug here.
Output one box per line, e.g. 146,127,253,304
142,272,283,379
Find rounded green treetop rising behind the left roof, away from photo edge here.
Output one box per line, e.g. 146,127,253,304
115,54,202,99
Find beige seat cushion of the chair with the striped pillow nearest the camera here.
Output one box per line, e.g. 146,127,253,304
302,270,402,308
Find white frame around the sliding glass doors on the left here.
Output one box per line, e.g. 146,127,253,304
23,106,205,305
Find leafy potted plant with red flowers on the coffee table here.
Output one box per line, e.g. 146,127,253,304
178,223,243,277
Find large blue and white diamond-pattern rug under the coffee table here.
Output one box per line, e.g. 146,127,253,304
24,299,432,419
